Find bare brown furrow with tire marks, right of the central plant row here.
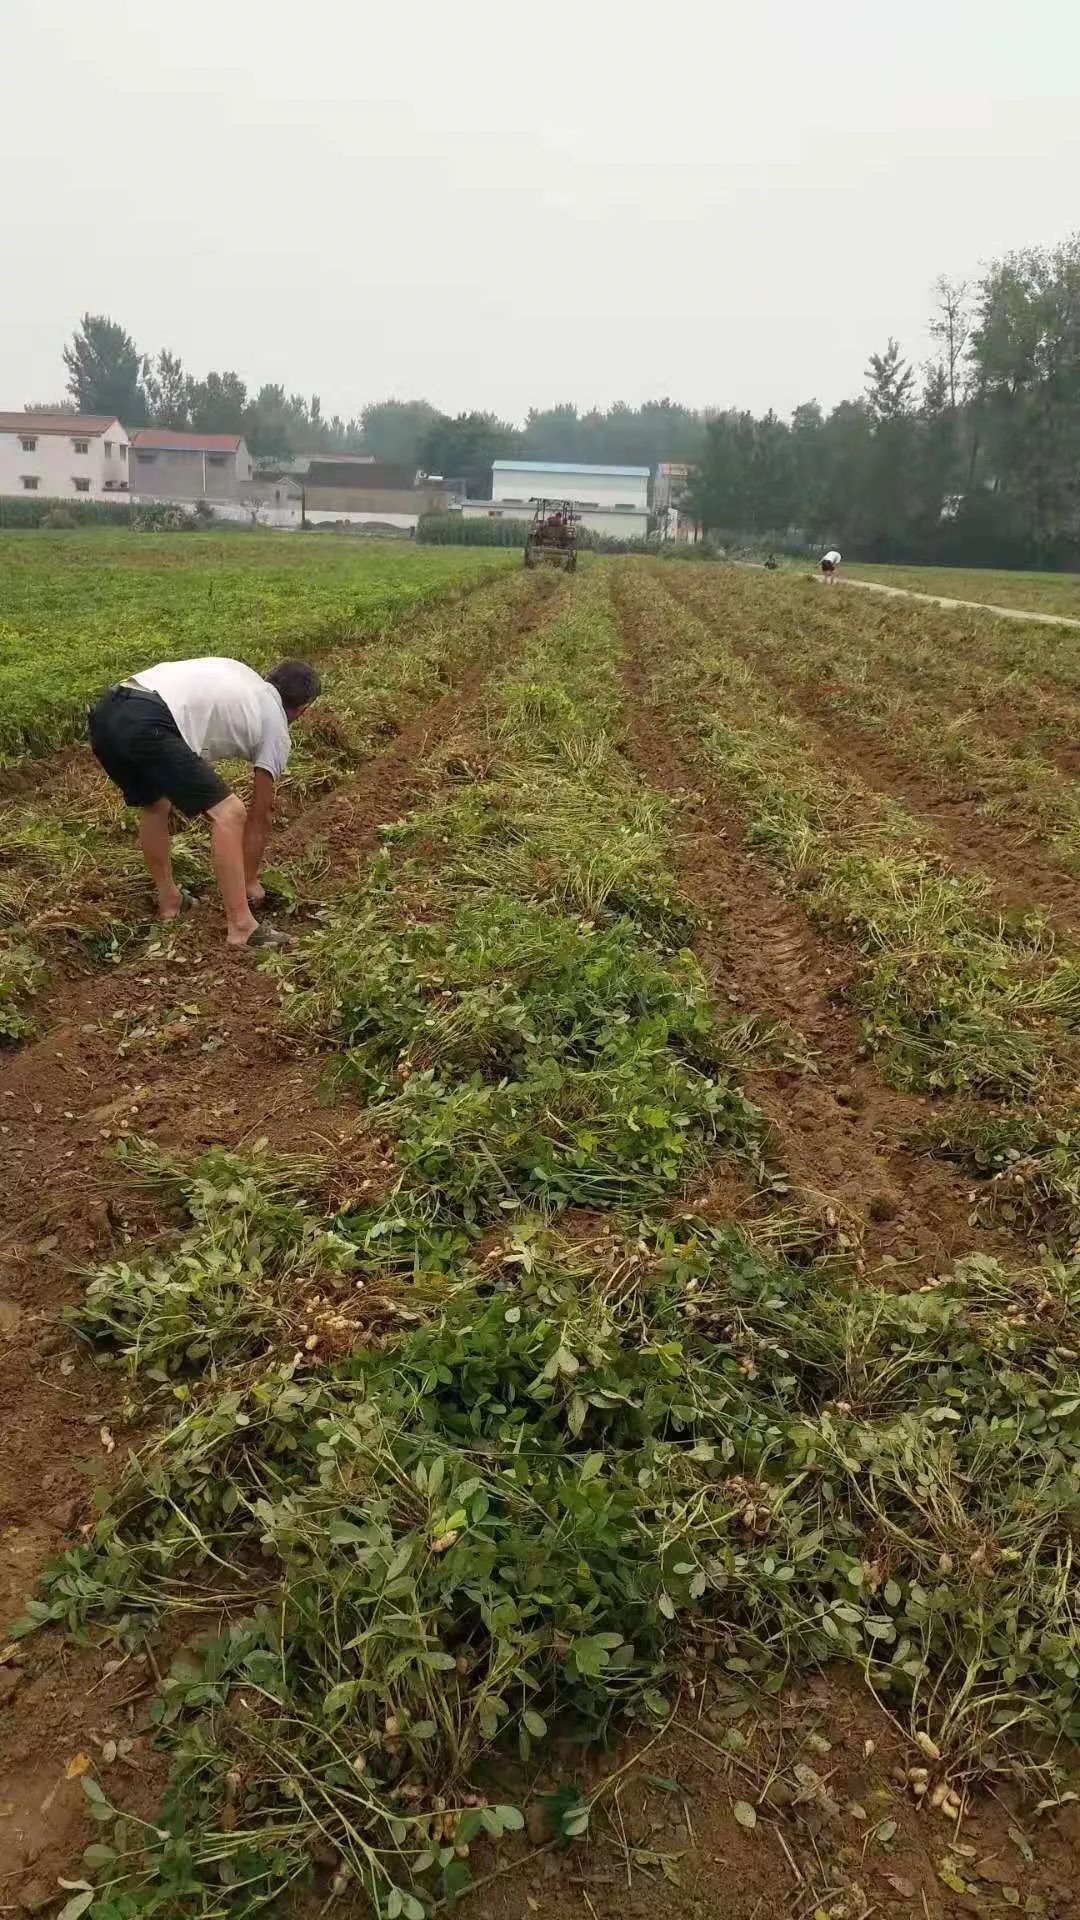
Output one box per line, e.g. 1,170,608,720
623,576,1030,1284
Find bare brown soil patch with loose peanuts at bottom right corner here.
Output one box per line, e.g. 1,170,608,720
453,1672,1080,1920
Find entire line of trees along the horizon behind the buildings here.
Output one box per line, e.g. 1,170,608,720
44,234,1080,566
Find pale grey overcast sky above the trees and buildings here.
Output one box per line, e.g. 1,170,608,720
0,0,1080,419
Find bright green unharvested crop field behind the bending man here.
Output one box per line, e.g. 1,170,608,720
0,528,515,762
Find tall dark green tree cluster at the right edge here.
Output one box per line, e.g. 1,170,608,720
688,236,1080,566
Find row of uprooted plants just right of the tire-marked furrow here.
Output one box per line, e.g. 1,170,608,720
634,564,1080,1252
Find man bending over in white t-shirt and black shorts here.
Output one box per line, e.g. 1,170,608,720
88,659,319,947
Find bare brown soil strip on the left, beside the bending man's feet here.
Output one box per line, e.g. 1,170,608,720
0,582,557,1910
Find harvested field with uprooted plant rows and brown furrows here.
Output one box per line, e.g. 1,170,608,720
0,540,1080,1920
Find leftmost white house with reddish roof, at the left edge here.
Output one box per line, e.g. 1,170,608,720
0,413,129,499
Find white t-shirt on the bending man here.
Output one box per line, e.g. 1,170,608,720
133,660,292,780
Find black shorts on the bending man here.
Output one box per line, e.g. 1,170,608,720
88,687,229,820
